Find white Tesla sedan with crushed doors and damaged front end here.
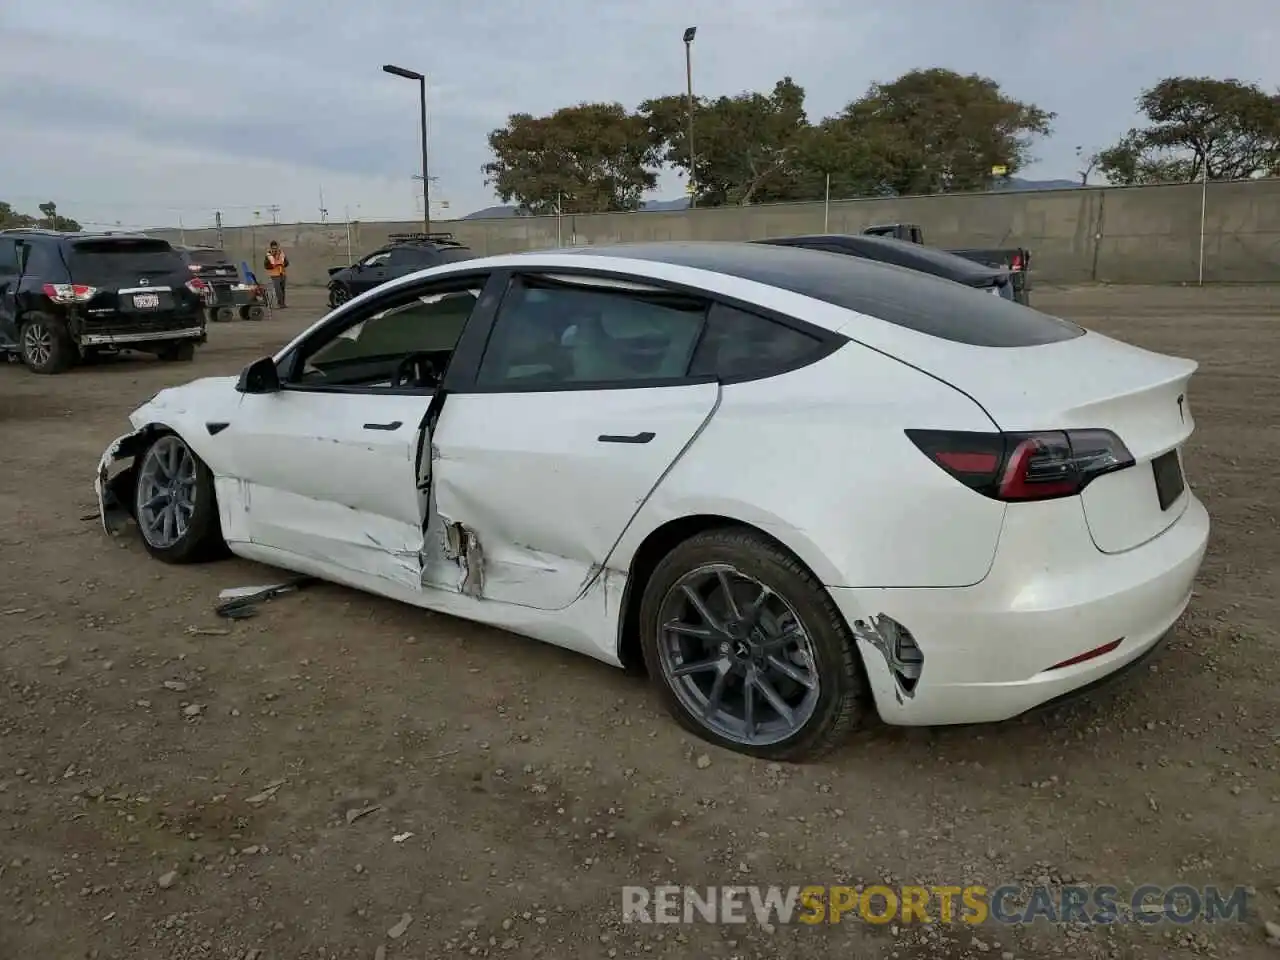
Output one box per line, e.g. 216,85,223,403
95,243,1210,759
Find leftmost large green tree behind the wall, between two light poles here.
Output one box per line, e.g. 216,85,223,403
483,104,658,214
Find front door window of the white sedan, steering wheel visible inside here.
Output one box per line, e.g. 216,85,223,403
294,276,486,388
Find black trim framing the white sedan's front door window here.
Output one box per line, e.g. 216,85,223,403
275,268,507,397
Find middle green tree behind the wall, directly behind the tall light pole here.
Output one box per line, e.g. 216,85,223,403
639,77,809,206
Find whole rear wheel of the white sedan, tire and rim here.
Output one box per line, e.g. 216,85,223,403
640,527,868,760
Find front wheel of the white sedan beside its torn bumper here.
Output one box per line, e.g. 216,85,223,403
133,434,225,563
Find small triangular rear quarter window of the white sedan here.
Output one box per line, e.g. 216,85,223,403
689,303,822,380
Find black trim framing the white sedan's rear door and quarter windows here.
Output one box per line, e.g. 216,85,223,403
443,265,850,394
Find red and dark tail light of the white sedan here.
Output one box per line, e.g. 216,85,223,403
906,430,1134,500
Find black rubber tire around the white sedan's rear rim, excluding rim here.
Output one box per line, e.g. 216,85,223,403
640,527,870,762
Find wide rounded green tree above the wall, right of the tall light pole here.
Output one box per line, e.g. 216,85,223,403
837,68,1055,195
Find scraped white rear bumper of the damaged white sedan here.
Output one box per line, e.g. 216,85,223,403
831,497,1210,726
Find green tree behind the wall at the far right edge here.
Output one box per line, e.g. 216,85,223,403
1098,77,1280,184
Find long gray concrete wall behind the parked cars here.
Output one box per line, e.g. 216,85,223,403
155,180,1280,284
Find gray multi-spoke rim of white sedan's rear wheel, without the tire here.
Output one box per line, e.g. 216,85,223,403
658,563,820,746
